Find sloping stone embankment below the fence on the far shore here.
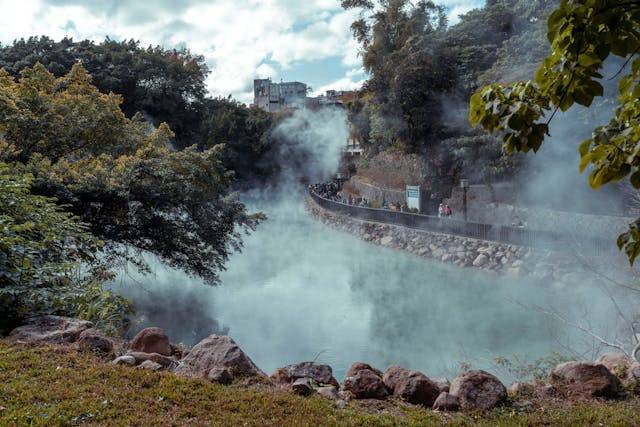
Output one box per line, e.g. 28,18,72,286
305,197,610,284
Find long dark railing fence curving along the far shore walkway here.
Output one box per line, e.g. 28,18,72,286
309,190,617,256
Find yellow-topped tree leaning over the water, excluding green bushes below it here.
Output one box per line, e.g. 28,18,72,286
0,63,261,283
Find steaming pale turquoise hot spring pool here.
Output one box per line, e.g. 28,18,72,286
111,194,624,379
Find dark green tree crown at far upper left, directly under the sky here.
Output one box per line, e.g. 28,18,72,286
0,36,209,147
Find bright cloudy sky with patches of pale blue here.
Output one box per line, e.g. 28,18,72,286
0,0,484,103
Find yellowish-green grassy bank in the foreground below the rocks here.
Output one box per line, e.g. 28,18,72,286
0,341,640,426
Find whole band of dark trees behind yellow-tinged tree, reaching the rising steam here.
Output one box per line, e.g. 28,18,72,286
0,36,276,184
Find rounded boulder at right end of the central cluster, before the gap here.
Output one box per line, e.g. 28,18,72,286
449,371,507,410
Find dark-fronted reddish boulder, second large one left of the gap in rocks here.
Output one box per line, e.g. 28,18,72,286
382,366,440,408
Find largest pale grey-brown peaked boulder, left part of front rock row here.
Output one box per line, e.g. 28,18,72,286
176,335,266,378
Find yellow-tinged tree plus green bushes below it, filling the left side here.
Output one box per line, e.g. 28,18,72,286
0,63,260,329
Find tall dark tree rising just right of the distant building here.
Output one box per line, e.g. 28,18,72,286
342,0,455,154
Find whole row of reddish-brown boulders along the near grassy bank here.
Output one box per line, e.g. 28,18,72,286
9,316,640,418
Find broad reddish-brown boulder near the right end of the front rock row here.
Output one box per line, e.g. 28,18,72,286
551,362,621,397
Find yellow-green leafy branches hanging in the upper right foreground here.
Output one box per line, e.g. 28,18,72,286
469,0,640,264
